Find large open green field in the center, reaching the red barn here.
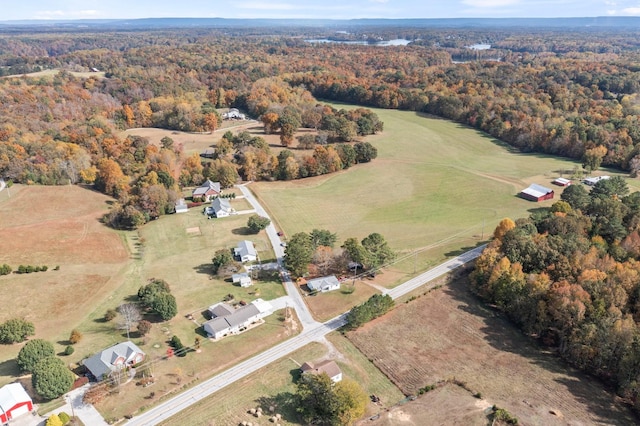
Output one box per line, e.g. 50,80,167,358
250,105,620,272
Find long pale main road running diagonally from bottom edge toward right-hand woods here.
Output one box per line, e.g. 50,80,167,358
127,246,484,426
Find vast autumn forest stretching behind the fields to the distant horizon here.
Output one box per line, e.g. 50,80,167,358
0,27,640,227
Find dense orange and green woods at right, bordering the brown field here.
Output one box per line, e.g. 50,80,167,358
472,177,640,409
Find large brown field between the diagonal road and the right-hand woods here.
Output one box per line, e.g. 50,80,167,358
348,280,637,425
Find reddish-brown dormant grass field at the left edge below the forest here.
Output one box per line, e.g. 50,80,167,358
0,185,129,382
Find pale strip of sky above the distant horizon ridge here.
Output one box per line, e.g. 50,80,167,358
0,0,640,20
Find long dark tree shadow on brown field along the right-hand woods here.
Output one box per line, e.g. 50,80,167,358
443,274,638,424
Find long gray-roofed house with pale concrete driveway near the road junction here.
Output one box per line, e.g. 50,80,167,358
203,299,273,339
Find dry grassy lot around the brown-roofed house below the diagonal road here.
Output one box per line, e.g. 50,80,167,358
162,333,403,426
